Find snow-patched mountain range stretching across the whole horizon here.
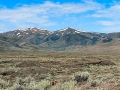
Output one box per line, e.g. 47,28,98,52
0,27,120,51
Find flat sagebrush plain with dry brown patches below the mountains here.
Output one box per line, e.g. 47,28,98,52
0,52,120,90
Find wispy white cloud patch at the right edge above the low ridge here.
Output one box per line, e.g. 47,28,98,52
92,2,120,32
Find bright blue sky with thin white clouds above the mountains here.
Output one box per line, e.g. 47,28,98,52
0,0,120,33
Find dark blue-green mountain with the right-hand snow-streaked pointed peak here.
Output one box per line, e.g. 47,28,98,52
40,27,102,50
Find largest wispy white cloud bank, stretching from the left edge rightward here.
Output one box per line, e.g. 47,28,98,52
0,0,101,30
